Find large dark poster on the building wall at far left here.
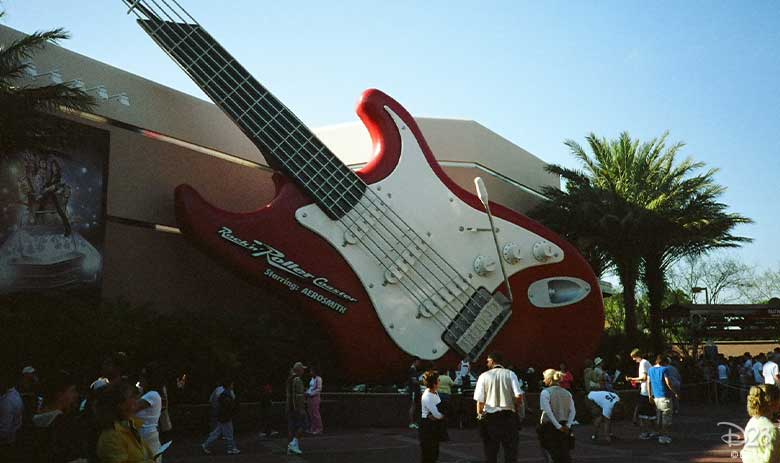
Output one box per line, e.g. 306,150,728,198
0,122,109,294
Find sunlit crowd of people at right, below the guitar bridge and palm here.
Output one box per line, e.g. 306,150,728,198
409,348,780,463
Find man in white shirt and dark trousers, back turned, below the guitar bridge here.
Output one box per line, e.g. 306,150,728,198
474,352,523,463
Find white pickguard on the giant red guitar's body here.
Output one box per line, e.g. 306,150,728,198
296,107,564,360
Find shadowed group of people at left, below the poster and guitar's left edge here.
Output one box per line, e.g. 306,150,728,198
0,352,324,463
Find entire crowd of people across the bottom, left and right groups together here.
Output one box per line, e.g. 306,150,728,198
0,348,780,463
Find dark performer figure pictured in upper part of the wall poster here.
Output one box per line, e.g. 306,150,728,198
20,156,71,236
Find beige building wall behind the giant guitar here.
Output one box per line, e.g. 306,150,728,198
0,26,558,310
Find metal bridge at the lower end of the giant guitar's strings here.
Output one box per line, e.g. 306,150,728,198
441,288,512,362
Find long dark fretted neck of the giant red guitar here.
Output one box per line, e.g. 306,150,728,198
138,19,366,220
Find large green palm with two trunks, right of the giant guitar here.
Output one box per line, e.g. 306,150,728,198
534,132,750,349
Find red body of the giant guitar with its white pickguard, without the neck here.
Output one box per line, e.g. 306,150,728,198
176,90,604,382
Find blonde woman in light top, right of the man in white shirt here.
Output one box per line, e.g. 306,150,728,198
537,369,577,463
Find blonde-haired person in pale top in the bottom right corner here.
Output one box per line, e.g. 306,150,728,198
739,384,780,463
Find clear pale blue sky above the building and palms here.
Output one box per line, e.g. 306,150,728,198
1,0,780,269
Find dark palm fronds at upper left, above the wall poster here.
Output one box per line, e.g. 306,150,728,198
0,11,95,156
